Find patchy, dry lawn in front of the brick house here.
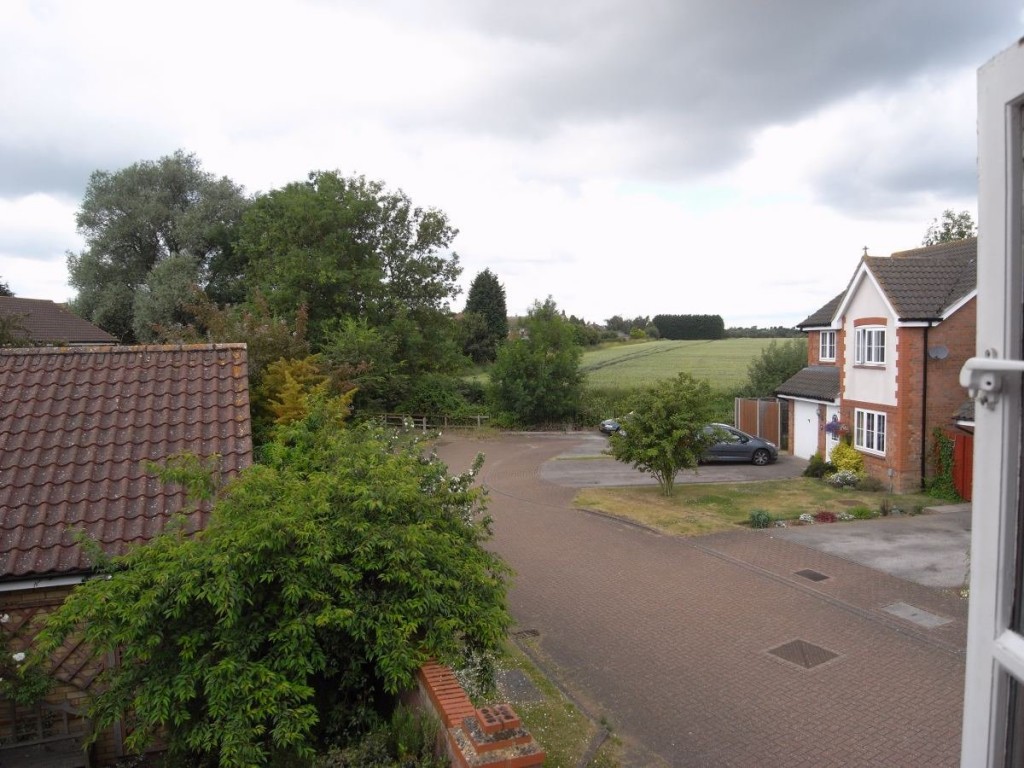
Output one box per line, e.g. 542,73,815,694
573,477,935,536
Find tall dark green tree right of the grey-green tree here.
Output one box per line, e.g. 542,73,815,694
240,171,461,340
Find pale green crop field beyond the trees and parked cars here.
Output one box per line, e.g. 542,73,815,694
582,339,786,389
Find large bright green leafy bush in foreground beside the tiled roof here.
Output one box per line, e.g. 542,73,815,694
36,402,510,766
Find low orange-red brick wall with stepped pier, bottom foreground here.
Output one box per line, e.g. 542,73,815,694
409,662,545,768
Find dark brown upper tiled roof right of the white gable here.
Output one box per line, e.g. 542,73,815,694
864,238,978,321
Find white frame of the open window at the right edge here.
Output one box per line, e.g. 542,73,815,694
961,39,1024,768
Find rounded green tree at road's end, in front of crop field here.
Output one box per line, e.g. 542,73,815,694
489,296,584,425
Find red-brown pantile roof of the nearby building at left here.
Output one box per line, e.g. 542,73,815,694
0,344,252,581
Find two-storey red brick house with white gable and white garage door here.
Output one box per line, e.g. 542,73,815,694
776,238,978,492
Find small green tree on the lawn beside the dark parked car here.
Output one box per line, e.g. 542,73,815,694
608,373,717,496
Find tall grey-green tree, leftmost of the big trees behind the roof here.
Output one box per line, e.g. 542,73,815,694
68,151,248,341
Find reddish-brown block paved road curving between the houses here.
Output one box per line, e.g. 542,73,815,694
438,434,967,768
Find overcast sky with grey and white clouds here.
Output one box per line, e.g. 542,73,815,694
0,0,1024,326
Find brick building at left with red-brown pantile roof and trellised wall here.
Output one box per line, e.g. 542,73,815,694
0,344,252,766
